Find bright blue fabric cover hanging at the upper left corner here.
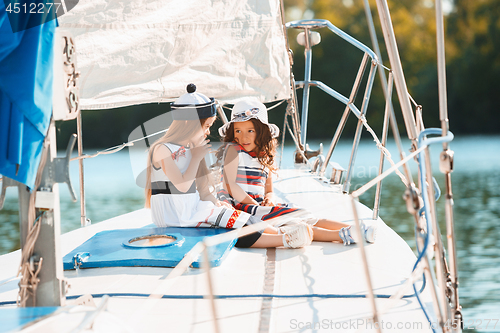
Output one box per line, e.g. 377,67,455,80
0,1,56,189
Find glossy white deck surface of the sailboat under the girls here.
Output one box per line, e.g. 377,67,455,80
0,170,434,332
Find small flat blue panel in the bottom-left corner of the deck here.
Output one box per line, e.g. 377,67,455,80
0,306,59,332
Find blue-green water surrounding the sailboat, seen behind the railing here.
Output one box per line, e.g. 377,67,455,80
0,136,500,332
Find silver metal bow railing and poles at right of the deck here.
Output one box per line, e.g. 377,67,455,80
278,7,461,331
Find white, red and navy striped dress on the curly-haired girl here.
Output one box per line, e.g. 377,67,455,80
218,143,318,224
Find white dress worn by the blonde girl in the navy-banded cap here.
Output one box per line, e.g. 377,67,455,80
151,143,250,228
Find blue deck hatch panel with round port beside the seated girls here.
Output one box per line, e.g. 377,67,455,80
63,228,237,270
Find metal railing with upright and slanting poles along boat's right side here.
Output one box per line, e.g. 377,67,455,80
285,4,462,332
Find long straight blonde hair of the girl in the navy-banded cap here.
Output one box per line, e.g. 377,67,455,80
145,117,214,208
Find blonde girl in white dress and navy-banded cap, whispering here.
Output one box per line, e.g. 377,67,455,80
146,84,311,248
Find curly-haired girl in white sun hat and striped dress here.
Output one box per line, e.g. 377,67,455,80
217,99,374,245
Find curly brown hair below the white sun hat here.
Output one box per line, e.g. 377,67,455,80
216,118,278,172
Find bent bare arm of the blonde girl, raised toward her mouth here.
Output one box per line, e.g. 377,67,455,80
153,141,211,192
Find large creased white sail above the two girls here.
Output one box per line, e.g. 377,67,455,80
59,0,290,110
